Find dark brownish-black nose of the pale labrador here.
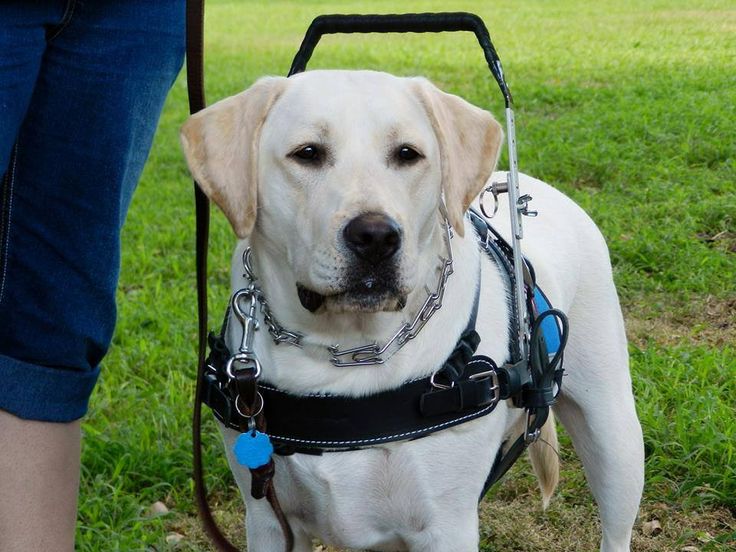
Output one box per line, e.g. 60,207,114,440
342,213,401,264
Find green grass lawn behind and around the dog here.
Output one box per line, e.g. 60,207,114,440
78,0,736,551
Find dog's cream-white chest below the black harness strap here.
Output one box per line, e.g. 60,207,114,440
276,414,506,550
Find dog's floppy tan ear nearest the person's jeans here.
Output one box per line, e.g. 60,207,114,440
179,77,287,238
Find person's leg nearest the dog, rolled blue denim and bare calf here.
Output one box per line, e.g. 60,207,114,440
0,0,184,551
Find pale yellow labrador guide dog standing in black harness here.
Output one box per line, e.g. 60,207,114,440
181,71,644,552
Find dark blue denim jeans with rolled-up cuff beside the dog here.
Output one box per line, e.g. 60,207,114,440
0,0,185,422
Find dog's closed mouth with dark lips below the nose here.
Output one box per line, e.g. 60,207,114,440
296,276,407,312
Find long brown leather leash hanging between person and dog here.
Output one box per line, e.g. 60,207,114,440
186,0,294,552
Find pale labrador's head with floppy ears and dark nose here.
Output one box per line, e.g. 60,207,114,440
181,71,502,313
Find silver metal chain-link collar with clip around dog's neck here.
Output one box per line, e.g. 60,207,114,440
231,220,454,367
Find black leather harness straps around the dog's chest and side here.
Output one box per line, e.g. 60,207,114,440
202,211,566,490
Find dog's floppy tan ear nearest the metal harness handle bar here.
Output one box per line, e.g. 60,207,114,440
414,78,503,236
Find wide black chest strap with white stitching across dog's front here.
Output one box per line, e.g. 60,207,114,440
203,330,502,454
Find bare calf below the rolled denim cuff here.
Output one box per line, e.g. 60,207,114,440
0,410,81,552
